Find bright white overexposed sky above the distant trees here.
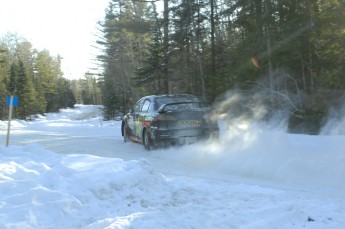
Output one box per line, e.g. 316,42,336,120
0,0,110,79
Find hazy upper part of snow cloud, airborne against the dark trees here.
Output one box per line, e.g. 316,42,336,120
208,74,303,130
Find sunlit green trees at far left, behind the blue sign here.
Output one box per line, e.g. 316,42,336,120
0,34,75,119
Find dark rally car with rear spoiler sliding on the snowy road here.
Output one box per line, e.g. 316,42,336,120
121,94,219,150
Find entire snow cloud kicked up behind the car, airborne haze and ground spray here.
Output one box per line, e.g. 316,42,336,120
161,78,345,191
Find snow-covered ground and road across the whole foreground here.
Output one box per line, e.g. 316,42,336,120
0,105,345,229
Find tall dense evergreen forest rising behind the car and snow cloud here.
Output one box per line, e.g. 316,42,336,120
97,0,345,131
